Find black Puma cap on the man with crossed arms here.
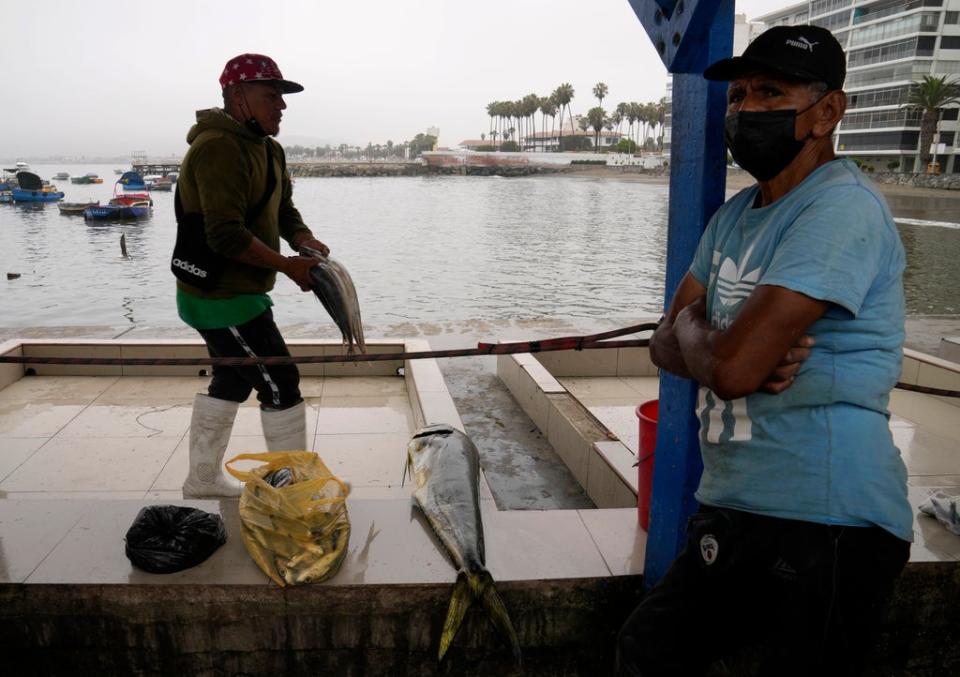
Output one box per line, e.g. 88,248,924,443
703,26,847,89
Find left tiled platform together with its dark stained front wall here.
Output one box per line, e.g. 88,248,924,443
0,341,646,675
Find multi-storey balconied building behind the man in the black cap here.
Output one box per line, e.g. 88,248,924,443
757,0,960,173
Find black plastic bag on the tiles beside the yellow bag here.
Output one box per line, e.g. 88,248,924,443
125,505,227,574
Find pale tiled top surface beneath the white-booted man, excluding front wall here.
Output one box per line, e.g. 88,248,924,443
0,341,645,585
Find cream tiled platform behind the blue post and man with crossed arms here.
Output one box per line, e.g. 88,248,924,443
498,348,960,562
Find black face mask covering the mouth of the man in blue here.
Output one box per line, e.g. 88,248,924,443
723,99,820,181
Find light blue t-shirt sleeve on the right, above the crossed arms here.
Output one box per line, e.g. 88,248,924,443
759,186,894,316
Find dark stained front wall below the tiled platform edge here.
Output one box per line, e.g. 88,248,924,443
0,577,641,677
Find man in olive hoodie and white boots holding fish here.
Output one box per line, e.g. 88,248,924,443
173,54,329,498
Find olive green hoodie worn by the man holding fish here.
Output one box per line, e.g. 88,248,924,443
177,108,309,298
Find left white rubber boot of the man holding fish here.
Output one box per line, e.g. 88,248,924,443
183,394,240,498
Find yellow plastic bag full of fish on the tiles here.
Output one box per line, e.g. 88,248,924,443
226,451,350,586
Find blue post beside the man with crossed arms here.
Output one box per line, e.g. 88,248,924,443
630,0,733,587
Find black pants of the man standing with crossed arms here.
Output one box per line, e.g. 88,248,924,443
617,507,910,677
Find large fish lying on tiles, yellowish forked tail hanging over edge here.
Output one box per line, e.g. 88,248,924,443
407,425,520,663
